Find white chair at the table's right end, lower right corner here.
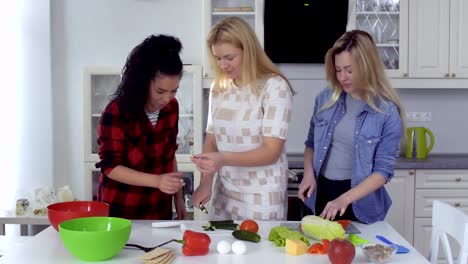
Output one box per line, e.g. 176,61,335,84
430,200,468,264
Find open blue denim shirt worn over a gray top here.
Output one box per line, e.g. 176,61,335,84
305,88,403,223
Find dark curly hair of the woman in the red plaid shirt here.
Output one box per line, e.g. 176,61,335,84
114,35,183,116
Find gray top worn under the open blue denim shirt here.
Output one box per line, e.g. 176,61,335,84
322,94,365,181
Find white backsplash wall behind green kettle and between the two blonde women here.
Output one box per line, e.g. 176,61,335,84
286,82,468,154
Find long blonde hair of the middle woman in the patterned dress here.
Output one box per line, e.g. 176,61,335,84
206,17,294,95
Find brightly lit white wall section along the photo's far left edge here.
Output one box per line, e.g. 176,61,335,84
0,0,54,209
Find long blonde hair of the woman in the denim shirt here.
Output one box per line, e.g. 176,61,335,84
323,30,404,120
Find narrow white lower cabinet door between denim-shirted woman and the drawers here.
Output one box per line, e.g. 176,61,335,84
385,170,416,243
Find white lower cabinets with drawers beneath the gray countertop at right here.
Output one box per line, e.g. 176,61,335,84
385,169,468,250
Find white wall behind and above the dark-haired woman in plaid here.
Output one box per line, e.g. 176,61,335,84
51,0,202,197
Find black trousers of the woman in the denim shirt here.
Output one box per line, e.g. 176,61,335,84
315,175,359,221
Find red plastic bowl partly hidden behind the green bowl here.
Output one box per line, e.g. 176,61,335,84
47,201,109,231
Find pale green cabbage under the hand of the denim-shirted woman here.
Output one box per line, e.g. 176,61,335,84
301,215,345,241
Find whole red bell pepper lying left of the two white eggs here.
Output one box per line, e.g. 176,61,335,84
176,230,211,256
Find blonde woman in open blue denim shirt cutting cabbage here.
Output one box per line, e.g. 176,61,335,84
299,30,403,223
